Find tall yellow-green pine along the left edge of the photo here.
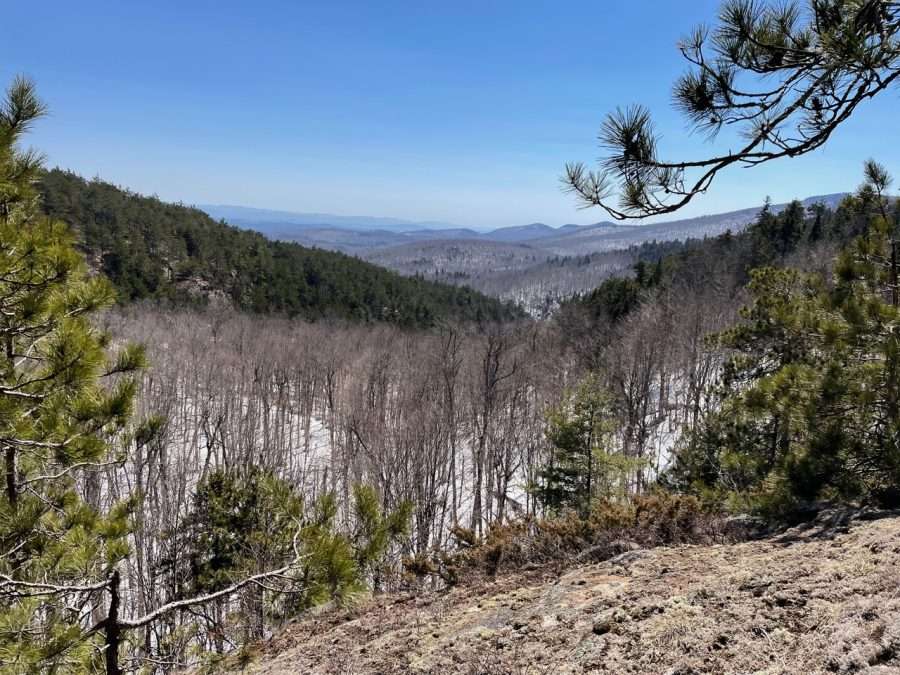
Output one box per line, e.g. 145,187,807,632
0,79,143,672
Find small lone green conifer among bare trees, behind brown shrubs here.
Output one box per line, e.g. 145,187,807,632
535,375,639,514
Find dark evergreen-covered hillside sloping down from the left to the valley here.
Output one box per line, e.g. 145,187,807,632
40,169,520,327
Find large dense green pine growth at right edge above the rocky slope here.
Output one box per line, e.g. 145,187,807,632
680,170,900,513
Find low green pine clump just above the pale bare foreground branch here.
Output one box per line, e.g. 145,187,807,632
179,467,412,614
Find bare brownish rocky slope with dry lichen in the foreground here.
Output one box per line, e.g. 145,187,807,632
223,512,900,675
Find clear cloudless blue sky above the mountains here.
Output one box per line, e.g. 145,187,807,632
0,0,900,226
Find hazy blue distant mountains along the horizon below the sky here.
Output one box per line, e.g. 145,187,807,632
197,193,846,256
